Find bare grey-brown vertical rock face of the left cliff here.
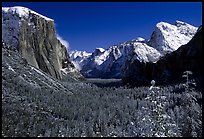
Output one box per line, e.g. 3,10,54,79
19,14,68,79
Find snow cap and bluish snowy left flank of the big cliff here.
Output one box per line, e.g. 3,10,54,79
2,6,53,47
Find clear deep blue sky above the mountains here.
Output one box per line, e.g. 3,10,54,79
2,2,202,52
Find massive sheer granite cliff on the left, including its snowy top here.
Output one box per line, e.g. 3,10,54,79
2,6,83,79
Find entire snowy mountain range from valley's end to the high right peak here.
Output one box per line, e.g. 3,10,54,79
70,21,197,78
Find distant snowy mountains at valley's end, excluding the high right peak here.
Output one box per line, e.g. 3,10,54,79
70,37,161,78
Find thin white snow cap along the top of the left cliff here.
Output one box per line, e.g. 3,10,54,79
2,6,54,21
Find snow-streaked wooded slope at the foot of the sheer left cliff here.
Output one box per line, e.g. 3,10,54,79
2,44,72,94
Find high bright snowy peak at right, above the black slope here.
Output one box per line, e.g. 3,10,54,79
148,20,197,54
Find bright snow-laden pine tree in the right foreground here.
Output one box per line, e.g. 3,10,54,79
147,82,180,137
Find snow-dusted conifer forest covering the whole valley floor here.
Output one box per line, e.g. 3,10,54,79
2,79,202,137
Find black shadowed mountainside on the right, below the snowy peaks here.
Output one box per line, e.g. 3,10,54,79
122,27,202,86
